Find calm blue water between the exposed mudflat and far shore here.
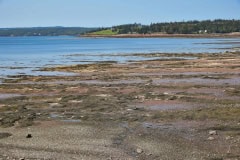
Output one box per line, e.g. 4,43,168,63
0,36,240,78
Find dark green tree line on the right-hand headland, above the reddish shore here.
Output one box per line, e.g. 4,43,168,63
108,19,240,34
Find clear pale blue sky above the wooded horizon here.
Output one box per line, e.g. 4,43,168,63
0,0,240,28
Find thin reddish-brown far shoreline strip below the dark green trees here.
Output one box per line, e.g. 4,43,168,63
80,32,240,38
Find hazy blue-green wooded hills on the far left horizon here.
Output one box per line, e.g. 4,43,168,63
0,27,96,36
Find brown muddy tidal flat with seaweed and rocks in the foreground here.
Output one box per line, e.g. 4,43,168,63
0,52,240,160
